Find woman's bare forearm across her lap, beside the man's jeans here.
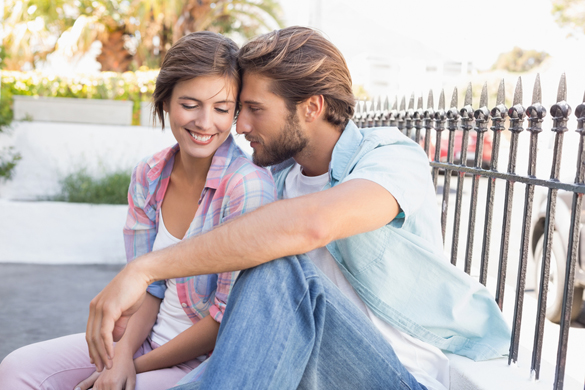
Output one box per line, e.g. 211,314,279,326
132,316,219,374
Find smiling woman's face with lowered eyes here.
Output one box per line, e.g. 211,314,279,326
163,76,237,158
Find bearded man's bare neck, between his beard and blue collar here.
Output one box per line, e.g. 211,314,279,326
294,123,341,176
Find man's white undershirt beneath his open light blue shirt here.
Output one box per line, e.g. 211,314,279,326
283,164,449,390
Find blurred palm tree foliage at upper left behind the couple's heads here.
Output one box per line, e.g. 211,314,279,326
3,0,282,72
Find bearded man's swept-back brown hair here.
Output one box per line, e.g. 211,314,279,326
238,26,355,130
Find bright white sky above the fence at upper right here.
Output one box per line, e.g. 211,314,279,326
280,0,582,69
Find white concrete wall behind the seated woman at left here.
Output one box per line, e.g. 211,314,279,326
0,122,250,264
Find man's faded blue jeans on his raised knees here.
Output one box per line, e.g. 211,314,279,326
173,255,426,390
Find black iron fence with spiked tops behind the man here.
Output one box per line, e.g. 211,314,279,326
354,75,585,390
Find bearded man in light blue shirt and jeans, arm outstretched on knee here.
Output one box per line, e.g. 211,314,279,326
87,27,509,389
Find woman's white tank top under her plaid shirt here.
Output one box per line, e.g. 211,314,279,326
150,208,193,345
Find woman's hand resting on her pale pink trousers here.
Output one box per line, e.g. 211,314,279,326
74,351,136,390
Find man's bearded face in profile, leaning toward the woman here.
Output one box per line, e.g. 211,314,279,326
236,73,308,166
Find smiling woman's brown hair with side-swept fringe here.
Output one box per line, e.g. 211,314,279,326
152,31,242,129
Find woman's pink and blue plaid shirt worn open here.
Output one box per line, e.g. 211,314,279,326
124,135,276,323
